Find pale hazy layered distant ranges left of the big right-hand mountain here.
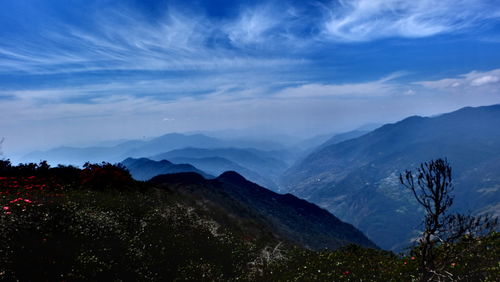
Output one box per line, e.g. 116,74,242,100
23,133,302,190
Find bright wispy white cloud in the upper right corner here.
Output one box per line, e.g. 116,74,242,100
325,0,500,41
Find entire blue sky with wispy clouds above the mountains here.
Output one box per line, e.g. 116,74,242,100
0,0,500,157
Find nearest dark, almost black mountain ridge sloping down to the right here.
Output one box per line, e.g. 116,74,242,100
150,171,376,249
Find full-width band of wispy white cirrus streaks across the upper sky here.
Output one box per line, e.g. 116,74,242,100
0,0,500,74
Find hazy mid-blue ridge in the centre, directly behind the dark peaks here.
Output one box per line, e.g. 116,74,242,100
151,148,289,190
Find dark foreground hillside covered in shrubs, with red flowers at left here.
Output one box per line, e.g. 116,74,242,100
0,161,500,281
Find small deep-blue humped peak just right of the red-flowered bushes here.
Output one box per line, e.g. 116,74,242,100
121,158,213,180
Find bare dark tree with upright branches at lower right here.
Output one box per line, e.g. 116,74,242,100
399,159,498,281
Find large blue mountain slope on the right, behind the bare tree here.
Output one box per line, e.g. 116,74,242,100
282,105,500,250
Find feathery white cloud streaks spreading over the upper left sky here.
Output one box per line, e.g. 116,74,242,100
0,6,304,74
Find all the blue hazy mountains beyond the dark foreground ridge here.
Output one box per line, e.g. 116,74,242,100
15,105,500,250
